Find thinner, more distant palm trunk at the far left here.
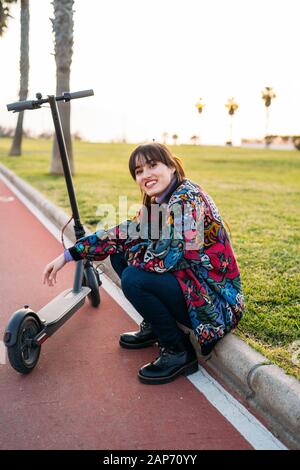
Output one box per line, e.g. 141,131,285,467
9,0,29,156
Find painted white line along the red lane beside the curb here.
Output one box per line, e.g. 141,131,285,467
0,174,287,450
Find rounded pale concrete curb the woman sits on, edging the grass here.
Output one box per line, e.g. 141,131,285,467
0,164,300,450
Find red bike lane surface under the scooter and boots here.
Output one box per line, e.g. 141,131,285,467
0,179,252,450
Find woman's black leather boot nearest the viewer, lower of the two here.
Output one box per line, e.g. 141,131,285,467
138,336,198,384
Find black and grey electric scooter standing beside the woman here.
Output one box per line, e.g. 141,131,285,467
4,90,101,374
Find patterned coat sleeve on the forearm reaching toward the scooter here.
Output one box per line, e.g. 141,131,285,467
69,220,130,261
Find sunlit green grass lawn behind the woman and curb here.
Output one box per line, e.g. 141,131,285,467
0,139,300,379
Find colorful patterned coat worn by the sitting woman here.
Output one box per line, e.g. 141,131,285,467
70,179,244,353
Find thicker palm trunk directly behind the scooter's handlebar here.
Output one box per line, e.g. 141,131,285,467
50,0,74,175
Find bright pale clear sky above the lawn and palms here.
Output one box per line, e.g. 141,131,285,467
0,0,300,144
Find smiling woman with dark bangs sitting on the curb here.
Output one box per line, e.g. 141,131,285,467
44,142,244,384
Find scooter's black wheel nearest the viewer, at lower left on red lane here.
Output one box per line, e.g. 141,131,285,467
7,315,41,374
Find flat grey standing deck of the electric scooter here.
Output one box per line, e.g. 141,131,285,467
37,286,91,325
